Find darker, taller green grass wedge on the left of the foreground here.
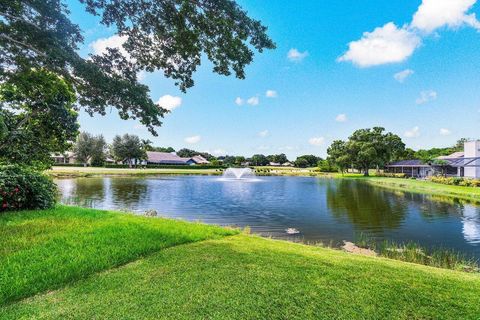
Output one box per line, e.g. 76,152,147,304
0,206,236,305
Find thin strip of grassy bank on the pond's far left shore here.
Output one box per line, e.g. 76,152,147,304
46,166,222,178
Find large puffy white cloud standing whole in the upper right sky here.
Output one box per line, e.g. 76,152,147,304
338,22,421,67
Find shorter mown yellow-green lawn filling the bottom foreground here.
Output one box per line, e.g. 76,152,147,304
0,235,480,319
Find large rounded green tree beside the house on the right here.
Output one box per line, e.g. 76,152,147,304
327,127,405,176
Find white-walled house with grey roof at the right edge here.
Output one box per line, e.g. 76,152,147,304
386,140,480,179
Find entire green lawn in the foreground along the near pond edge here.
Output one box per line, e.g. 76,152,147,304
0,206,480,319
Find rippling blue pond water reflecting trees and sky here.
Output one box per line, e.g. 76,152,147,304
56,176,480,259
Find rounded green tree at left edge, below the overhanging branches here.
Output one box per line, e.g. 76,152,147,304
0,69,78,168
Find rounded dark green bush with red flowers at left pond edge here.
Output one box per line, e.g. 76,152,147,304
0,166,57,212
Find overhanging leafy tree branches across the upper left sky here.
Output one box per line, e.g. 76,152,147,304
0,0,275,134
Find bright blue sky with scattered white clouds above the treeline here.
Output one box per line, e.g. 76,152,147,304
67,0,480,158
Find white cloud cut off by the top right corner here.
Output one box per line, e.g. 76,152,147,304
411,0,480,33
